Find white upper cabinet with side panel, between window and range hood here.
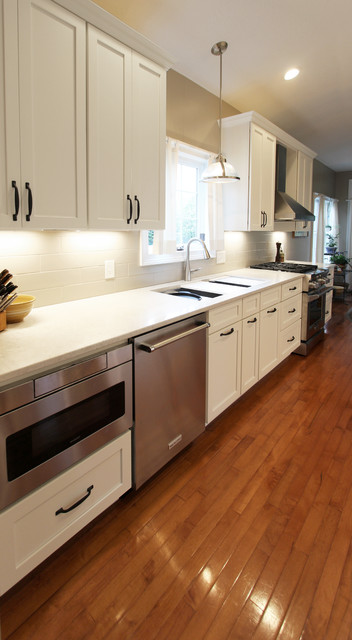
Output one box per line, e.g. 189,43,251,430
223,114,276,231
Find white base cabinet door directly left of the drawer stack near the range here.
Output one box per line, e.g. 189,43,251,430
259,305,280,378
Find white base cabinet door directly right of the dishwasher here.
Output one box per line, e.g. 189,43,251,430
207,322,241,423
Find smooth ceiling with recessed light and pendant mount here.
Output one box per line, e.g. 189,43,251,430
96,0,352,171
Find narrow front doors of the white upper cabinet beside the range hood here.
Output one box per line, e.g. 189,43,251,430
249,124,276,231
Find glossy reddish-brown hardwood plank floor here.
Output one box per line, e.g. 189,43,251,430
0,302,352,640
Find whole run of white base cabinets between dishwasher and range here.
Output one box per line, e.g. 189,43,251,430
207,278,302,423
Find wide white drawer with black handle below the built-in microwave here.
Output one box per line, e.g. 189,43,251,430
0,431,131,595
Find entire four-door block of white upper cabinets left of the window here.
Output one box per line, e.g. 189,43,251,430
0,0,170,230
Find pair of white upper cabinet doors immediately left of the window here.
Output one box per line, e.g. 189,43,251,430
88,25,166,230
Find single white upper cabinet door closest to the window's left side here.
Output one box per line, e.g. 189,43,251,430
126,52,166,229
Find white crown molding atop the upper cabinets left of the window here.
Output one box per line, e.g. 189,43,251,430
55,0,176,69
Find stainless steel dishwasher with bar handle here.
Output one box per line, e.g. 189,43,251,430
133,314,209,489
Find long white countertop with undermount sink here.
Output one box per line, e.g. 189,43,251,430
0,269,301,389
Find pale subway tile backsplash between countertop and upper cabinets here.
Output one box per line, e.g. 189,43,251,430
0,231,288,306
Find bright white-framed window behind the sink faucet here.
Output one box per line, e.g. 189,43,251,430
141,138,224,265
